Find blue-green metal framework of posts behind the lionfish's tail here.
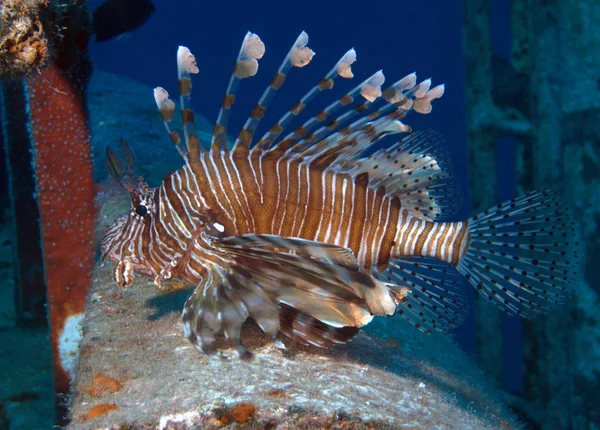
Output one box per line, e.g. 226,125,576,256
463,0,600,428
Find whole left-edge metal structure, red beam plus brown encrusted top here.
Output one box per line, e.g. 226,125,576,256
0,0,95,420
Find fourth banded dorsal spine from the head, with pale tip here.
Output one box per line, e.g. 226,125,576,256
234,31,315,152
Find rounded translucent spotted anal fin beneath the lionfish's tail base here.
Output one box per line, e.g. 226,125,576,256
374,257,468,333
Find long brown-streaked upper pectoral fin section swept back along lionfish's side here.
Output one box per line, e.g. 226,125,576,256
218,235,372,327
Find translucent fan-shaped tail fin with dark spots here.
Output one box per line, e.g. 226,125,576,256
456,191,578,318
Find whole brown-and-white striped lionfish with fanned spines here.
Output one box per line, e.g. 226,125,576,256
102,32,577,356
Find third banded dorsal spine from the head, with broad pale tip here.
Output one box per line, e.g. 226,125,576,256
211,32,265,151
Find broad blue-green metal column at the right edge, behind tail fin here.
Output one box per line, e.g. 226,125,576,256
513,0,600,429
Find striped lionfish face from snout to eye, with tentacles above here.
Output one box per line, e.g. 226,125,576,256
101,140,157,287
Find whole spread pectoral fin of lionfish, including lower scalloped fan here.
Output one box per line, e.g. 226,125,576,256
183,235,386,354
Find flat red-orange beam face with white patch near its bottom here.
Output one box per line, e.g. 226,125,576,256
27,63,95,394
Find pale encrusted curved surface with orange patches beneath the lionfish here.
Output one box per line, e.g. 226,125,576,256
69,193,516,429
